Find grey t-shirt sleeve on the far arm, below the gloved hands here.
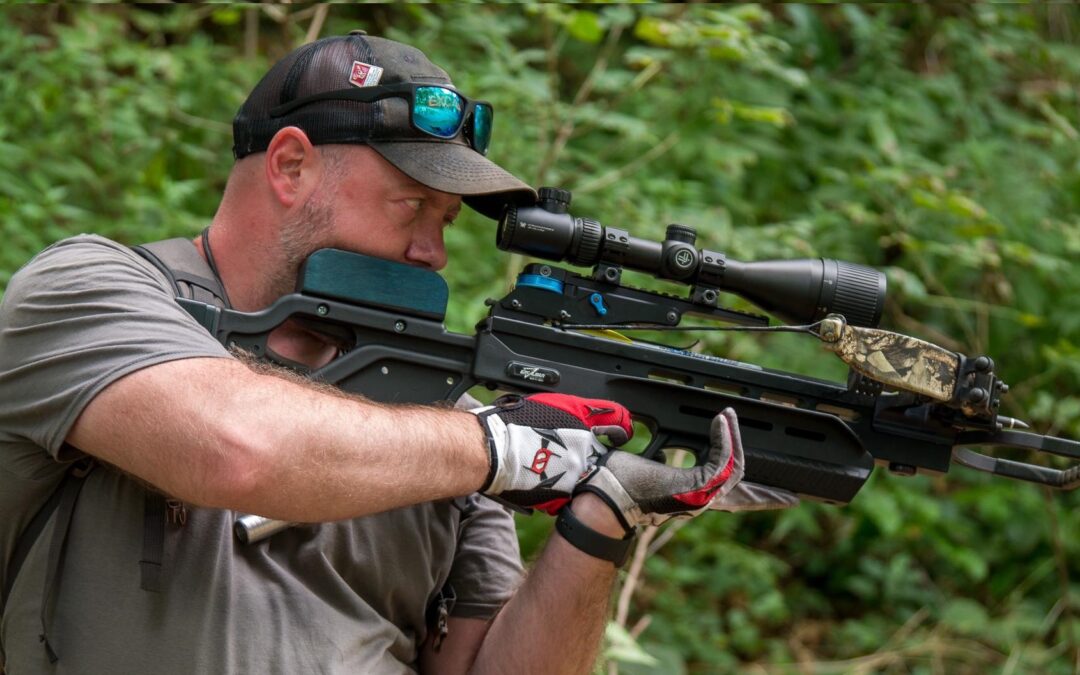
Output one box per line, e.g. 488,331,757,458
449,494,524,619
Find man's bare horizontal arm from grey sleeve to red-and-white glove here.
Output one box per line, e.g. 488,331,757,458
68,359,489,522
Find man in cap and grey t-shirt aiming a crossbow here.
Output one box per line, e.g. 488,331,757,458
0,32,794,673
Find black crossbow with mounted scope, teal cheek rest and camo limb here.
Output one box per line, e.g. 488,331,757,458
172,188,1080,539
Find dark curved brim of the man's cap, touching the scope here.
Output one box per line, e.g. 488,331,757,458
367,140,537,219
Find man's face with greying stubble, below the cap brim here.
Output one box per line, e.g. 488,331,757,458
295,146,461,270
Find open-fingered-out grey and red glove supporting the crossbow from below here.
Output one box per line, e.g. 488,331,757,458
577,408,798,531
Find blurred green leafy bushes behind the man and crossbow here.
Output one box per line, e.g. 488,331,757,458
0,4,1080,673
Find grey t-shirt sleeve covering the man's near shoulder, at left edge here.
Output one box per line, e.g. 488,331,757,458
0,235,230,458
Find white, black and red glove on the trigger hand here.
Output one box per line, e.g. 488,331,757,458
470,393,634,515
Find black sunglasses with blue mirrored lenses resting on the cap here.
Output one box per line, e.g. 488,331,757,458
270,82,495,154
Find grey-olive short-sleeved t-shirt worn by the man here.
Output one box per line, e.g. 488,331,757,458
0,235,522,675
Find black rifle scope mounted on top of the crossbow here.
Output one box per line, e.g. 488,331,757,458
497,188,886,327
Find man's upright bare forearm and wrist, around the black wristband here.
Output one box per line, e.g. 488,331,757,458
472,495,623,675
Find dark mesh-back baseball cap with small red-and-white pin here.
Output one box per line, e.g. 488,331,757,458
232,30,536,218
